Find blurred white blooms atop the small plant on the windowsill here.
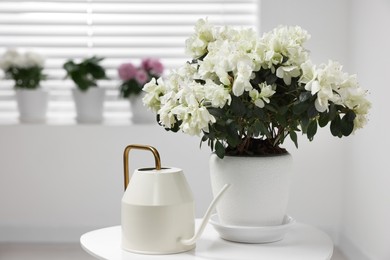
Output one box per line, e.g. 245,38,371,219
0,49,44,71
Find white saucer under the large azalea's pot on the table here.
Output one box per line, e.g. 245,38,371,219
210,214,295,243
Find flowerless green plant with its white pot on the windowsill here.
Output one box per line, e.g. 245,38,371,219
63,56,107,123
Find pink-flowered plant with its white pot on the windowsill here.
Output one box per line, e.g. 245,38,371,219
118,58,164,123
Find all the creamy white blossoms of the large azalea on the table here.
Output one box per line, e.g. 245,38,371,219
144,20,370,135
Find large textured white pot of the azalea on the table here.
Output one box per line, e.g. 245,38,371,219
210,154,293,227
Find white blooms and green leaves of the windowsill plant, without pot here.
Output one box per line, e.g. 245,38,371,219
0,49,46,89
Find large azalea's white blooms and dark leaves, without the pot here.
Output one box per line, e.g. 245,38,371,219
143,20,370,158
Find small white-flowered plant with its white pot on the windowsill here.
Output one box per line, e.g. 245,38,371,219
0,49,49,123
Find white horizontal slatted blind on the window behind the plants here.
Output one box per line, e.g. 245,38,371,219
0,0,259,124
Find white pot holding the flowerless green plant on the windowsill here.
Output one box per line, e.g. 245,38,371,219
72,87,105,123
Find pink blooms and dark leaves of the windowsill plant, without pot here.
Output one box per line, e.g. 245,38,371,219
118,58,164,98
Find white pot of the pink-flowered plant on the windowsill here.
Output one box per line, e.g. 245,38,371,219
129,94,156,124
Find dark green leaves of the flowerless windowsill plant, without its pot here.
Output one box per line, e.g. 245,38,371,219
63,56,107,91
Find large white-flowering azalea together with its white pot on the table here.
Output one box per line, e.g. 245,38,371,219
143,20,370,232
